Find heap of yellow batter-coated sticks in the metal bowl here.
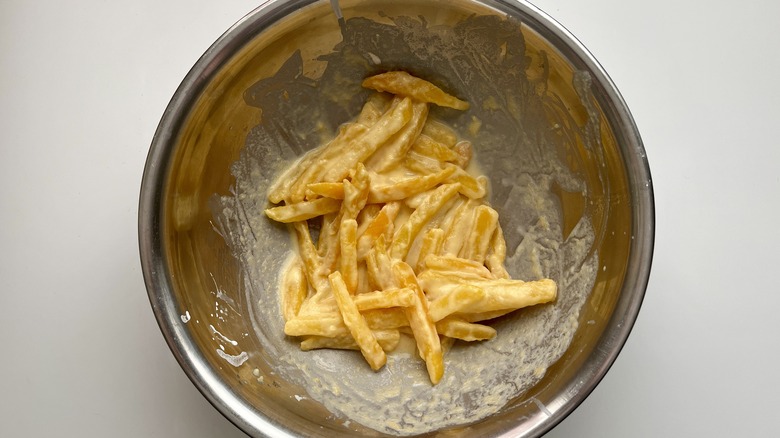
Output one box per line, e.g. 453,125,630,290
265,71,557,384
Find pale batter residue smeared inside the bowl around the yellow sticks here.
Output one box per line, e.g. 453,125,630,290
213,12,598,435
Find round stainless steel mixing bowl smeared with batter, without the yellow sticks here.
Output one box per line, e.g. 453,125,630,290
139,0,654,437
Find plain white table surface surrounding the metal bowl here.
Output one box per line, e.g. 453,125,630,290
0,0,780,438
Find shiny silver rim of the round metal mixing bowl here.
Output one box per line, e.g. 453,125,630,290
138,0,655,437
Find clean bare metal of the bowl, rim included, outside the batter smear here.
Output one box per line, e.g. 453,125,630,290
139,1,654,437
